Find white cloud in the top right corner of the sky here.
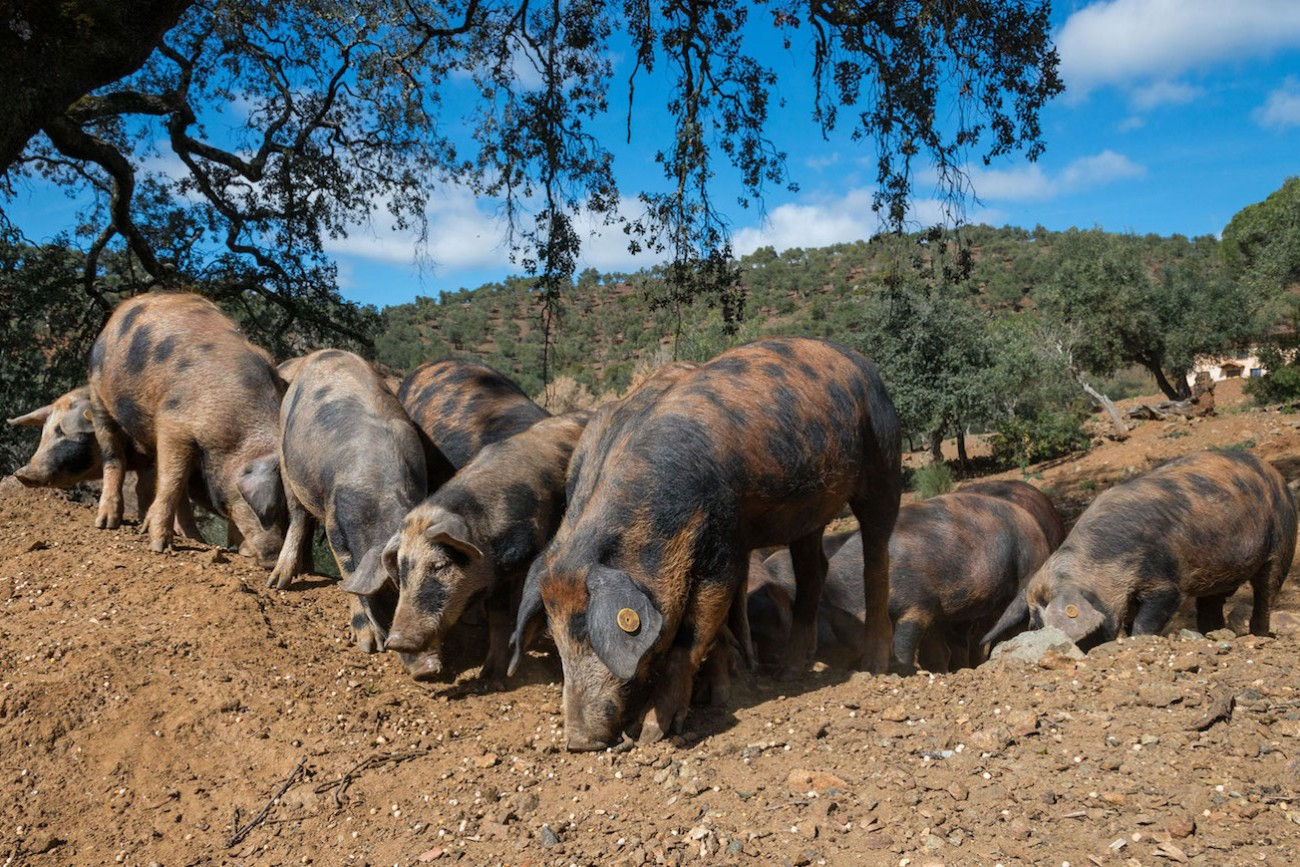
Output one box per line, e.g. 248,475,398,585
1057,0,1300,97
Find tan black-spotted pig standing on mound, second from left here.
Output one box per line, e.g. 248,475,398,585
88,292,287,567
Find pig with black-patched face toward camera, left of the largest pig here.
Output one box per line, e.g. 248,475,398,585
358,413,586,680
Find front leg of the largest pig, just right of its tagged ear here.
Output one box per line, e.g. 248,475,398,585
641,579,743,744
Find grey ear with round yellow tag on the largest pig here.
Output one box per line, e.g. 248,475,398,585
586,565,663,680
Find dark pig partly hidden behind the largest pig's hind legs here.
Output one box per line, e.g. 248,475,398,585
749,490,1050,673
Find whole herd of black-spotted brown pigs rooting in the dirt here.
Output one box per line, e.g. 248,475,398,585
10,292,1296,750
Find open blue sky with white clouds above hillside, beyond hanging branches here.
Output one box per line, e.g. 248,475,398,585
9,0,1300,305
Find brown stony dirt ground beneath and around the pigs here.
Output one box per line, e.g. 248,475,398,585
0,382,1300,867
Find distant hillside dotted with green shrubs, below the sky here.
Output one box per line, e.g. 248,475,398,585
376,225,1214,395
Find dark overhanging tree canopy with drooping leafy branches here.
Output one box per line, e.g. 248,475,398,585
0,0,1062,338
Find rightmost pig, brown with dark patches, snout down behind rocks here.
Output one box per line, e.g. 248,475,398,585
984,451,1296,650
